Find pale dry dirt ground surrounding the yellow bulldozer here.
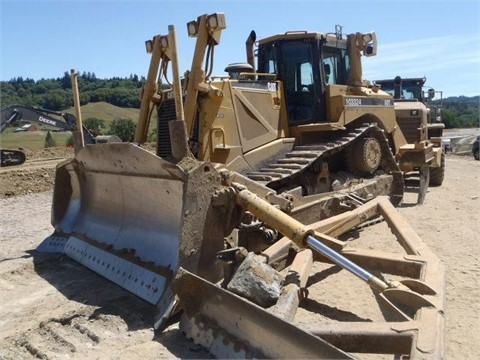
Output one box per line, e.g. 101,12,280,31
0,149,480,360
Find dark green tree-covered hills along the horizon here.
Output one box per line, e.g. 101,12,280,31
0,72,480,128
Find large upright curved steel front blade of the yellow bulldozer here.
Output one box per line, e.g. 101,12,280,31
38,143,224,326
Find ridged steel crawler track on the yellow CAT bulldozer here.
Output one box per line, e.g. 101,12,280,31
246,124,403,200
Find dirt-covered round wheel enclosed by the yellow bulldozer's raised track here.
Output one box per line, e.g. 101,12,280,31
349,137,382,175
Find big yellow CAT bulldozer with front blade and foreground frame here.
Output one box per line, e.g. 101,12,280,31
39,13,444,359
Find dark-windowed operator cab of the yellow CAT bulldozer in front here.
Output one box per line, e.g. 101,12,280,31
258,31,350,126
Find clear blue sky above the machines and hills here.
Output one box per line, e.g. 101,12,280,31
0,0,480,98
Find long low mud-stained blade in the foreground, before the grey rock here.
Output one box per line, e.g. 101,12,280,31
174,269,352,359
